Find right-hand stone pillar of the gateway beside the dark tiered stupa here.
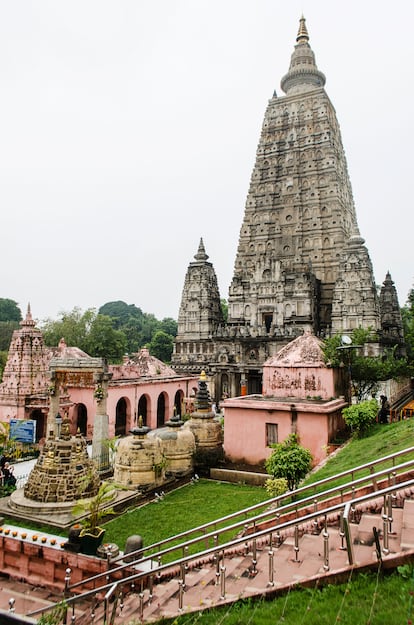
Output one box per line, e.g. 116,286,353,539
92,372,112,471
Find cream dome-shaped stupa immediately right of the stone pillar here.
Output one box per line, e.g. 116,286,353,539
114,416,165,490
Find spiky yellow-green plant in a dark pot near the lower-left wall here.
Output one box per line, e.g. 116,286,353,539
72,482,117,555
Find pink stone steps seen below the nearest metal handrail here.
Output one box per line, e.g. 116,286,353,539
111,500,414,625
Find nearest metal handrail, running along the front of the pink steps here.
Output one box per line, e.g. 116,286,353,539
28,479,414,616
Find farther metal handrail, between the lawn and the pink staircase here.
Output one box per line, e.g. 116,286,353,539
70,448,414,590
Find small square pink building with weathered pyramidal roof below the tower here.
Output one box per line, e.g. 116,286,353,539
223,333,347,465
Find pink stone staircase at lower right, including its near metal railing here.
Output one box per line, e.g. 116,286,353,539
62,481,414,625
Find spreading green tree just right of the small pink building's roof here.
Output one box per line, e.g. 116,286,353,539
324,328,411,401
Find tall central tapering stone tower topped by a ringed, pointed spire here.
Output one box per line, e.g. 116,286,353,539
229,18,379,335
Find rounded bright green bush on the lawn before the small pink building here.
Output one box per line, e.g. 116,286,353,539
265,434,312,490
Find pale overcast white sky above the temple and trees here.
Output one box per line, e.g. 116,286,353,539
0,0,414,320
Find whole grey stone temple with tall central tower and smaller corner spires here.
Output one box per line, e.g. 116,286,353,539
172,17,403,400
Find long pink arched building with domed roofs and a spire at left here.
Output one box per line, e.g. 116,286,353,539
0,306,198,441
